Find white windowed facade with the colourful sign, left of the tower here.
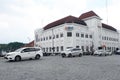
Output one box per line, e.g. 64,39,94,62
35,23,92,53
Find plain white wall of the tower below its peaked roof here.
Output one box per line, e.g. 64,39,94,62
84,16,102,50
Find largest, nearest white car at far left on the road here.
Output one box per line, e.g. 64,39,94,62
4,47,43,61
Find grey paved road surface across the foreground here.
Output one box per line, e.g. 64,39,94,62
0,55,120,80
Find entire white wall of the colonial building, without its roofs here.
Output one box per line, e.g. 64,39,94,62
35,17,119,52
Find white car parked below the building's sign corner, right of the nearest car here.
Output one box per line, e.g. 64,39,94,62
61,48,83,57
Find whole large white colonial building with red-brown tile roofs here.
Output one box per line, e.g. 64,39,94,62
35,11,119,53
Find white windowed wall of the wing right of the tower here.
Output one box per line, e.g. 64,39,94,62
102,28,119,51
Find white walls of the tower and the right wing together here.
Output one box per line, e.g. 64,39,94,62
81,16,119,51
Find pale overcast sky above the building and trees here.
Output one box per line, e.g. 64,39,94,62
0,0,120,44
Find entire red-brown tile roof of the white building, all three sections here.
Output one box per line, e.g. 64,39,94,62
44,11,117,31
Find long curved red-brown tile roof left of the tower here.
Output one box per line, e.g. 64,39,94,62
44,16,87,30
